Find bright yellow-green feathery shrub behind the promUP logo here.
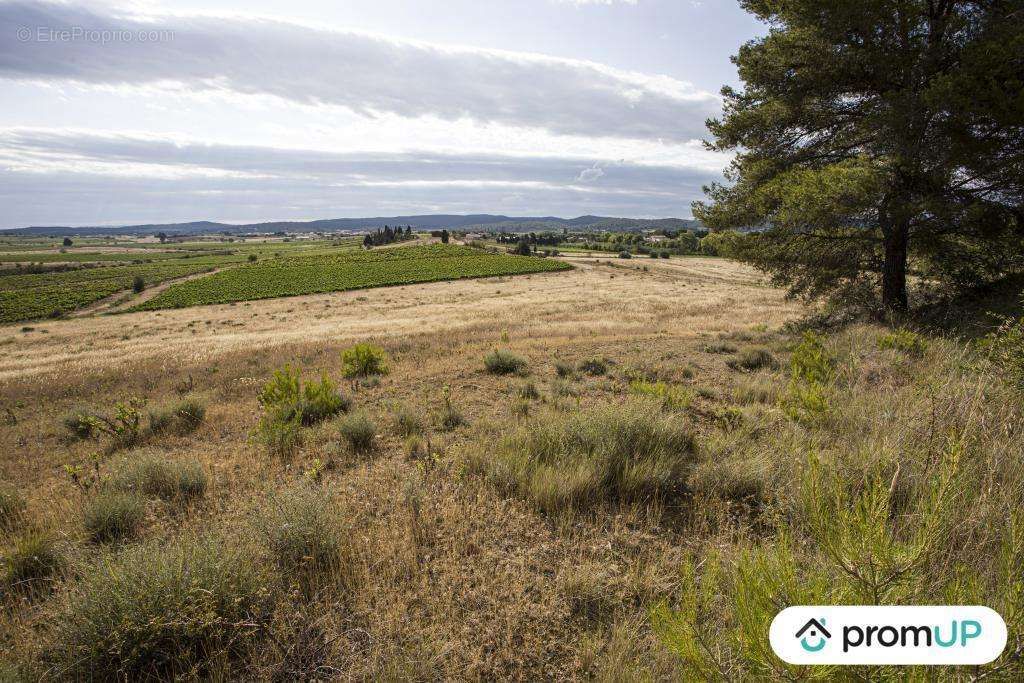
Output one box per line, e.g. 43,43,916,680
652,448,978,681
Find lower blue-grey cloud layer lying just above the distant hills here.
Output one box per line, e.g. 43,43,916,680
0,128,717,227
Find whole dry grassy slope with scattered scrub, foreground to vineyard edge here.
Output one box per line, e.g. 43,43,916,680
0,253,1024,680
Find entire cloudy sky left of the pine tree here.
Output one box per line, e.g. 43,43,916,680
0,0,765,227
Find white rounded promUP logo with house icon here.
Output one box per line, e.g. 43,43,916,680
768,605,1007,665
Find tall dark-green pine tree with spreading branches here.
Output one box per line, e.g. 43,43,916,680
694,0,1024,313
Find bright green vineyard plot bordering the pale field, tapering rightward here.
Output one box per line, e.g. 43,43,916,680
136,245,571,310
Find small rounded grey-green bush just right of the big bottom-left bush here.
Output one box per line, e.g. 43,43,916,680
258,486,350,588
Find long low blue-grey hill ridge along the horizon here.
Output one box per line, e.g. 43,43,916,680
0,214,700,237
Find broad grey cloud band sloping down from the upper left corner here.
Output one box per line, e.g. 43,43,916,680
0,2,721,142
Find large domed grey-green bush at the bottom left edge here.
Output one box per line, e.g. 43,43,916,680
46,541,271,680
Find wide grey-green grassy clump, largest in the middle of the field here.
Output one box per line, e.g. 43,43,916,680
468,403,695,513
